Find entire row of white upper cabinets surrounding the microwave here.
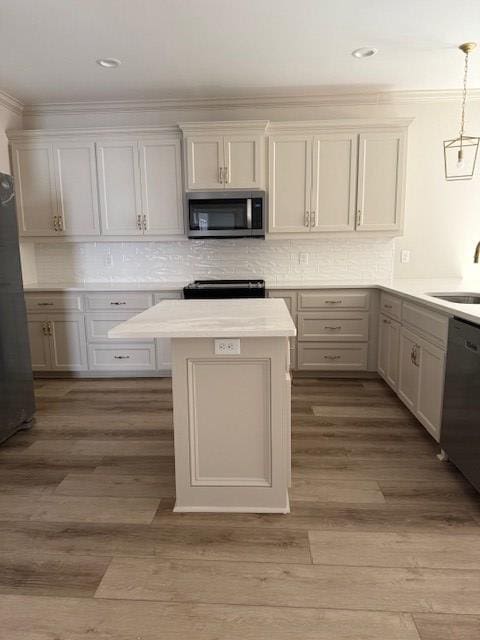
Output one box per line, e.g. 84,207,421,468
10,118,409,241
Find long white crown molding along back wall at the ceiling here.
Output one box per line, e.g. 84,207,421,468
22,89,480,116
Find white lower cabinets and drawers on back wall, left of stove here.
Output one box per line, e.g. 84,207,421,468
26,291,182,376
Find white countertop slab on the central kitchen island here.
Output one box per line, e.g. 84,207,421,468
108,298,296,339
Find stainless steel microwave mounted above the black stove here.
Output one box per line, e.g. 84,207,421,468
187,191,265,238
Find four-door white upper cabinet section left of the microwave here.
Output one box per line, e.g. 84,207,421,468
12,131,184,238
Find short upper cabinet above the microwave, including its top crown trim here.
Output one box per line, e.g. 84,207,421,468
180,122,267,191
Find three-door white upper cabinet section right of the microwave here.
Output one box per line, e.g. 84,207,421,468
269,122,407,234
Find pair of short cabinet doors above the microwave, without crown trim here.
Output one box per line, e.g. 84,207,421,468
185,133,265,190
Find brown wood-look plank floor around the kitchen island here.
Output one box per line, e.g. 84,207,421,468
0,378,480,640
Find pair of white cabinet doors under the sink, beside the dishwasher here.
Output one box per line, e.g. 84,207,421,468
398,327,446,442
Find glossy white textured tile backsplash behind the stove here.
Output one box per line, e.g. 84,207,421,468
35,238,394,283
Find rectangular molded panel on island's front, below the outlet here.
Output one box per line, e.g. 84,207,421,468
188,358,272,487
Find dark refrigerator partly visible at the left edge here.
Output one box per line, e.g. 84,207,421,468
0,173,35,443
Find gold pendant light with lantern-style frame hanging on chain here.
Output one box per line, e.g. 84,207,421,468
443,42,480,180
